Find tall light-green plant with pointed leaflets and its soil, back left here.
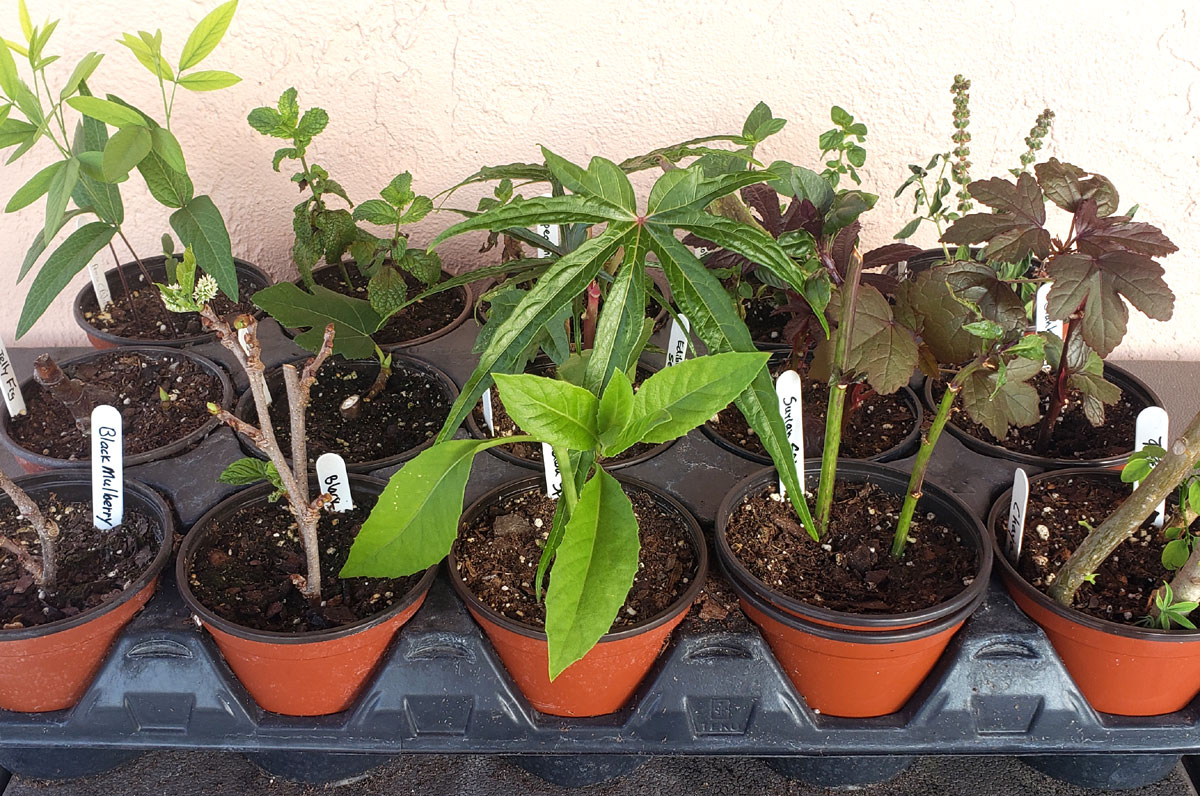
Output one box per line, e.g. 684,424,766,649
0,0,266,347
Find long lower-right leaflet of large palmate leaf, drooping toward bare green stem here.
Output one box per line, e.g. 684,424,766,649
650,227,818,539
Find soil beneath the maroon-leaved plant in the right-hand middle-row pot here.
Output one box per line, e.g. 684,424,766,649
934,373,1146,460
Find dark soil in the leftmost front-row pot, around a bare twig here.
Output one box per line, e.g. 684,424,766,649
0,492,158,630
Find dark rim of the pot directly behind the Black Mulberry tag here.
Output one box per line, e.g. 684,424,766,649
0,346,233,473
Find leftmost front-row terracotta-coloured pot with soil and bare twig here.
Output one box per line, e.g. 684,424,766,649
0,471,174,712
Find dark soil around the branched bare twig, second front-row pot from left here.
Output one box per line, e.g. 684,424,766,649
188,493,424,633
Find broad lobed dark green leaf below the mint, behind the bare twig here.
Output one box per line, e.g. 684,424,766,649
253,282,381,357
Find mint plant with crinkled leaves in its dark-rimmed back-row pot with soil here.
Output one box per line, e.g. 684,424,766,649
247,88,470,348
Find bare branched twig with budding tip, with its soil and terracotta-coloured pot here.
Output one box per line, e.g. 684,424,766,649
162,258,434,716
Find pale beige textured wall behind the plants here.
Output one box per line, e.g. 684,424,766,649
0,0,1200,359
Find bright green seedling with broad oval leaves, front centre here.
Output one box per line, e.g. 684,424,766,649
341,353,768,680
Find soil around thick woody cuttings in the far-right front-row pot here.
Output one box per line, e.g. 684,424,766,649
1017,475,1172,624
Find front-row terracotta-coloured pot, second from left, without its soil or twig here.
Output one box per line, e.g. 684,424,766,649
175,475,437,716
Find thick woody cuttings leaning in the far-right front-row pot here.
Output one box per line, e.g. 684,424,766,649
1049,414,1200,606
